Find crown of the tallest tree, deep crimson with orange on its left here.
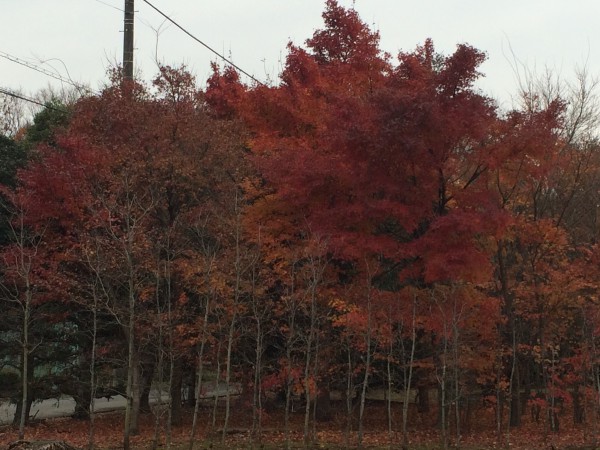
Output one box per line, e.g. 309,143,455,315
207,1,499,424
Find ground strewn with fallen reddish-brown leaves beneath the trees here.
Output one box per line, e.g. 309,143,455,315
0,402,600,450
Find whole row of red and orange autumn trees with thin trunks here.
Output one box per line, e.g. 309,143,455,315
0,0,600,449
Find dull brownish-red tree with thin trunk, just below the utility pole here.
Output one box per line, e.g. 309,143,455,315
7,67,248,446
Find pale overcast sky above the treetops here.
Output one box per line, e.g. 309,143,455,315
0,0,600,110
